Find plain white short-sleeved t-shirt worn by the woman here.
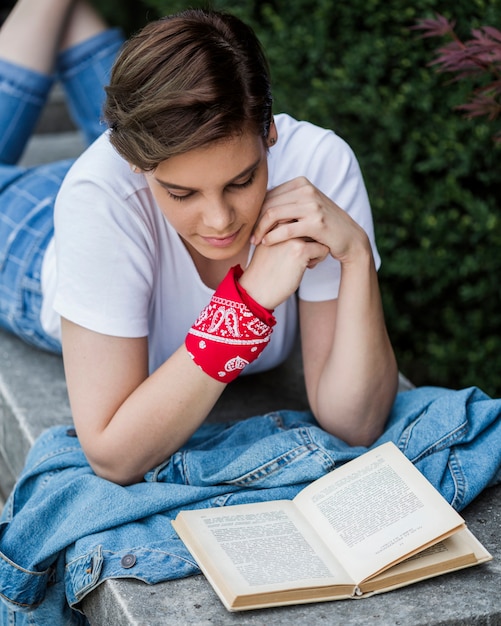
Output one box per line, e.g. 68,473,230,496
41,114,380,373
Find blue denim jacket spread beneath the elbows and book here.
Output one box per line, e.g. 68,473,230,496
0,387,501,626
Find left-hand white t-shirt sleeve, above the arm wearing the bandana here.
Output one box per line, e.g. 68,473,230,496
54,168,155,337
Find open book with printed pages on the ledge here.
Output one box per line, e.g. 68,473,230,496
172,443,492,611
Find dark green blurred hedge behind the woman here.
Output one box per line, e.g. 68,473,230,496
94,0,501,396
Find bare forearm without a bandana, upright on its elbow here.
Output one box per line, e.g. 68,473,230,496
311,245,398,445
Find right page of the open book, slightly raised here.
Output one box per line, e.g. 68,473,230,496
294,443,464,583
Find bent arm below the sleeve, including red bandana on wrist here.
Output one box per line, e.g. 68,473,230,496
62,267,275,484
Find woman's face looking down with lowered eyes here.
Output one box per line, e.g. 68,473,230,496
145,126,275,261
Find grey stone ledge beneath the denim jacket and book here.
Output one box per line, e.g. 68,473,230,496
0,331,501,626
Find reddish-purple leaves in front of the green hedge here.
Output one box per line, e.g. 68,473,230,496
413,13,501,142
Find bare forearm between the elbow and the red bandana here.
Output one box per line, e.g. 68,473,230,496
70,345,225,484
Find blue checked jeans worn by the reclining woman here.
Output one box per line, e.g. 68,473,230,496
0,29,123,352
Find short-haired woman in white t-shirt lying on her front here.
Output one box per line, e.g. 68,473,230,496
0,0,397,484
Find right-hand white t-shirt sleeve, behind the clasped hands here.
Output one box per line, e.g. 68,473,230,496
276,116,381,302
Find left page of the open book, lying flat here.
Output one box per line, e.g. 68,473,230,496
173,501,354,595
